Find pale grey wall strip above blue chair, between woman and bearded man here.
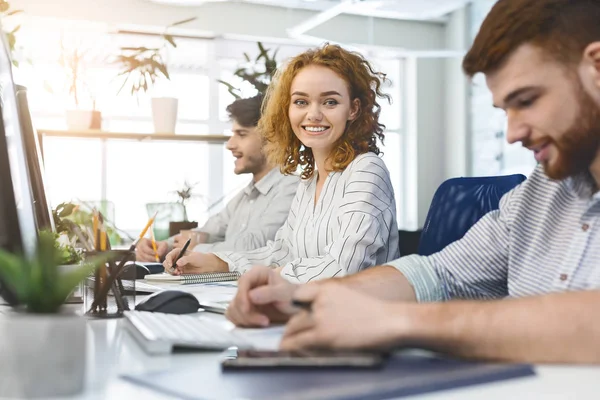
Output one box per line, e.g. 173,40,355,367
404,8,470,229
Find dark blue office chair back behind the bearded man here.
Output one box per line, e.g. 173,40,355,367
419,174,525,256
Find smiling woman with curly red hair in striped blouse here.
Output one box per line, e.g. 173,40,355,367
165,44,399,282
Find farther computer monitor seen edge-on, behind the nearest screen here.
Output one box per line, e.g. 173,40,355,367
17,85,55,232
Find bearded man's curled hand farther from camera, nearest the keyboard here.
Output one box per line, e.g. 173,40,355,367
225,266,298,327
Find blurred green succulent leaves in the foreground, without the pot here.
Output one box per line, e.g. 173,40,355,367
0,232,111,314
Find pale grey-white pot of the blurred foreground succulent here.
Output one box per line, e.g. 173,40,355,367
0,313,87,399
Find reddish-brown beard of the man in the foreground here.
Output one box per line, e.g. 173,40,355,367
523,79,600,180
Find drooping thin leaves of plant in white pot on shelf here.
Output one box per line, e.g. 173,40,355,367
115,17,196,96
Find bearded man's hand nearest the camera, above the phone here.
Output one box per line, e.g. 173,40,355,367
280,282,404,350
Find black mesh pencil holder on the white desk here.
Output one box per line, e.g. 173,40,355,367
82,250,136,318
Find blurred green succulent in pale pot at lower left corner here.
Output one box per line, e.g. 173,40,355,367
0,232,106,398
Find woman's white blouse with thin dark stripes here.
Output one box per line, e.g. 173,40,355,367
215,153,399,282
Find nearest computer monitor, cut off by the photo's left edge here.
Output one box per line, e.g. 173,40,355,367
0,27,37,304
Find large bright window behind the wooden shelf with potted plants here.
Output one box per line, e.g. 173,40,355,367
15,18,223,234
